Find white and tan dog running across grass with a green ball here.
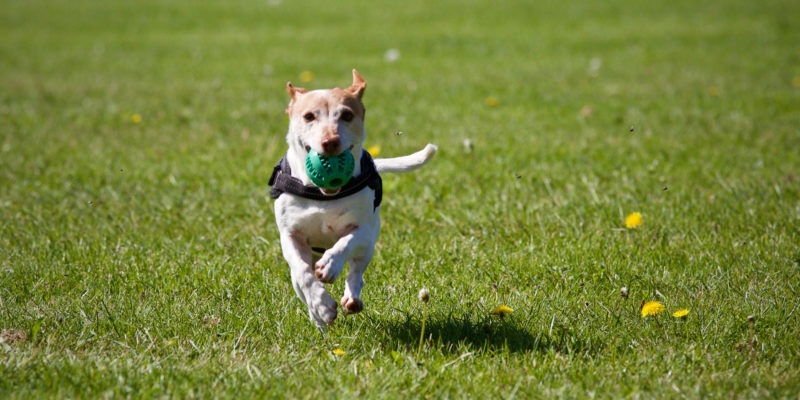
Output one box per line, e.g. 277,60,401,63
270,70,436,329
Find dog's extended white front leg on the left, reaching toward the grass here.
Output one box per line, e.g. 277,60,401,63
281,232,337,329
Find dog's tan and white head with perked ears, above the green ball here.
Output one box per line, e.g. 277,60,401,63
286,70,367,159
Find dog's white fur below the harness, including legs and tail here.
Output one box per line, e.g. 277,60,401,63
275,144,436,328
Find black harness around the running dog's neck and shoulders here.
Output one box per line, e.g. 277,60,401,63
269,150,383,208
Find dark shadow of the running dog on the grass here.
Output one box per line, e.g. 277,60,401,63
370,315,599,354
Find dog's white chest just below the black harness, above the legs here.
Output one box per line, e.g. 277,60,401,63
275,188,378,248
